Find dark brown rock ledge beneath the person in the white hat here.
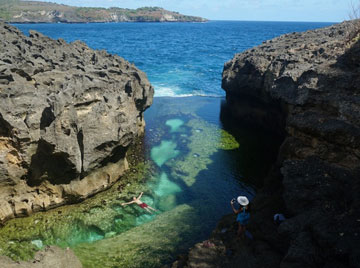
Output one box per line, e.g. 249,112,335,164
169,215,281,268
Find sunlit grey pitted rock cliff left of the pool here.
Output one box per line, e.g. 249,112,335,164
0,23,154,222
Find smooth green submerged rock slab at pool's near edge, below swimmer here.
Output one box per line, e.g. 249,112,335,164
74,205,203,268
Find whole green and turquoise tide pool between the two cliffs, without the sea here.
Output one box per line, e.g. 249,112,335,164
0,97,276,267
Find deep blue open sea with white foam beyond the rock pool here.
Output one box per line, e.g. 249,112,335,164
16,21,332,96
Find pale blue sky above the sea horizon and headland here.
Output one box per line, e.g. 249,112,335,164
38,0,352,22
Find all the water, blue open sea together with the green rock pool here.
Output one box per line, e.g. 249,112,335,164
0,22,328,267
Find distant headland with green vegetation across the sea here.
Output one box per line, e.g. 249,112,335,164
0,0,207,23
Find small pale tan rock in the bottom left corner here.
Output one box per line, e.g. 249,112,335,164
0,246,83,268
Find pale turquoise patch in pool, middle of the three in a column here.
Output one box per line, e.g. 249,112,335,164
151,140,180,167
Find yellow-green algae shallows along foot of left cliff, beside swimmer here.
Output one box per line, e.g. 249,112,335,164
0,158,150,260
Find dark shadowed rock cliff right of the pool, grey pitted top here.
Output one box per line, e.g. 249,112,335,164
222,21,360,267
